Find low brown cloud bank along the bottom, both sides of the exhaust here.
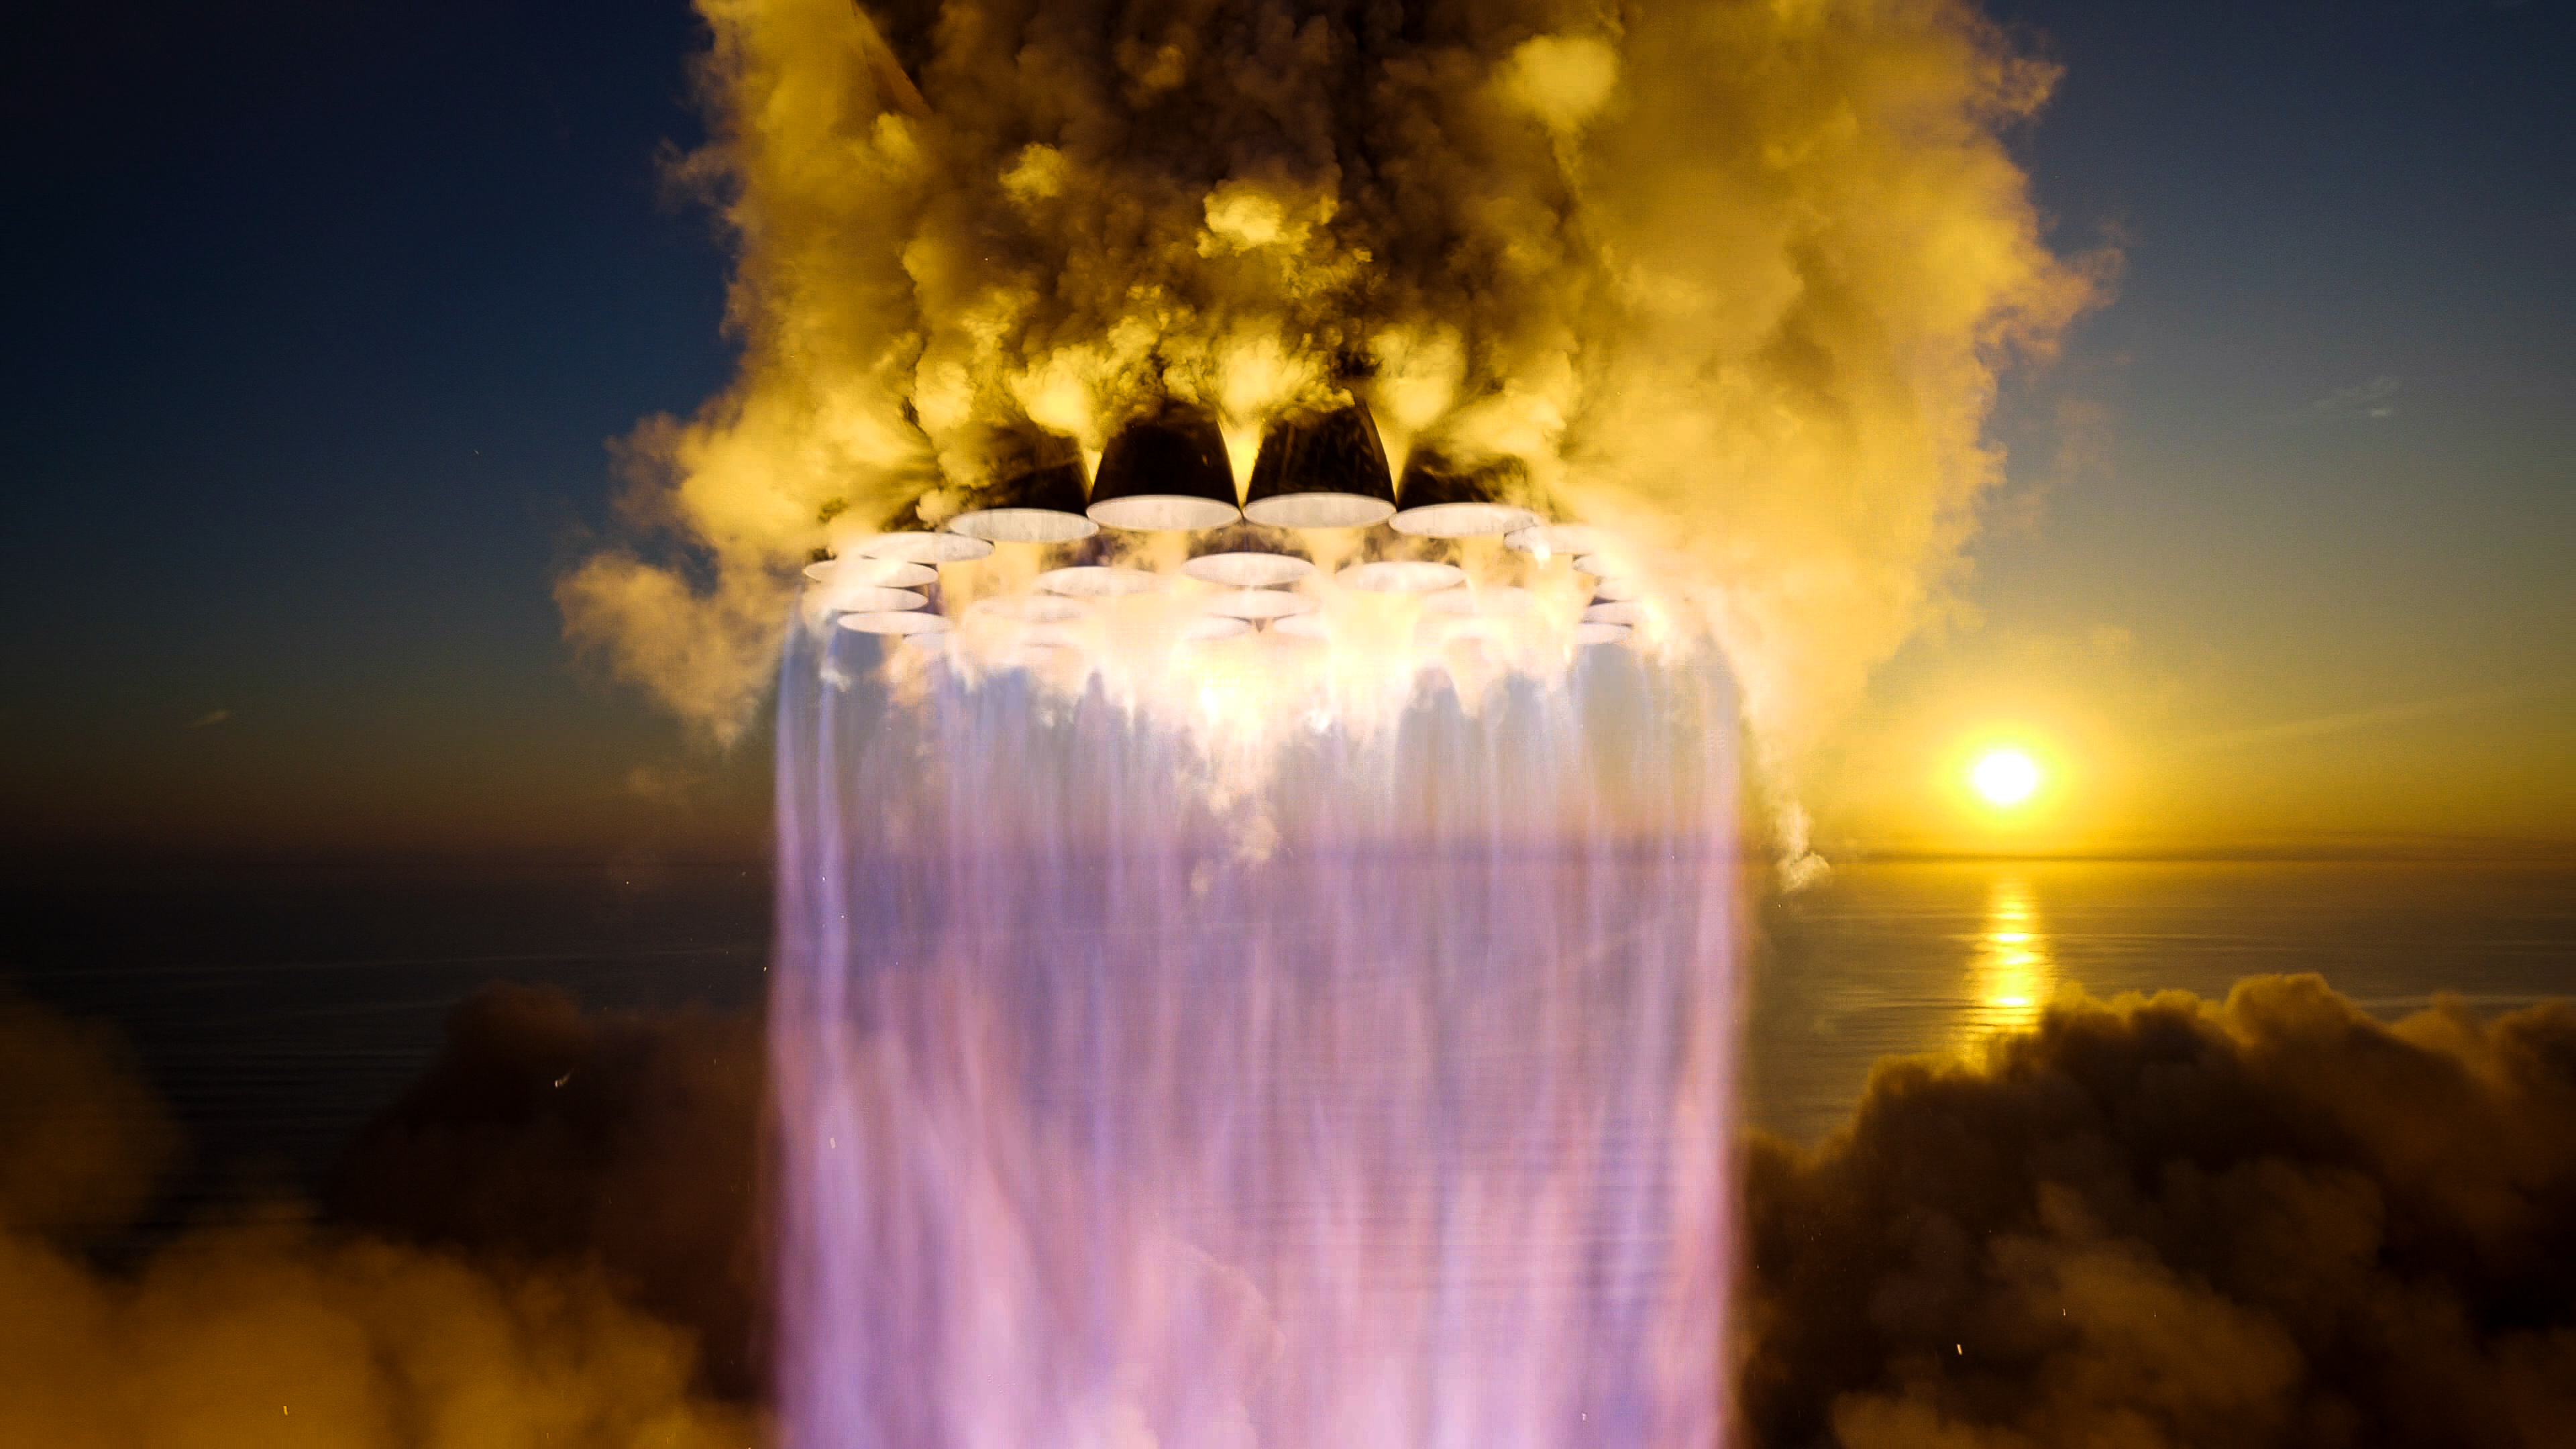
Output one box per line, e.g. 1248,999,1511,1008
0,977,2576,1449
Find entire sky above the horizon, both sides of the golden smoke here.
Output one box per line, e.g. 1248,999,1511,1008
0,0,2576,856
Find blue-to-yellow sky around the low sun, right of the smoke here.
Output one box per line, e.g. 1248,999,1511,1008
1819,3,2576,851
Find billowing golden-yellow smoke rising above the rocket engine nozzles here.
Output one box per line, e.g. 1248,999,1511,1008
559,0,2089,773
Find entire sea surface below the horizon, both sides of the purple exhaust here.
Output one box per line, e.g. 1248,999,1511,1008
0,864,2576,1212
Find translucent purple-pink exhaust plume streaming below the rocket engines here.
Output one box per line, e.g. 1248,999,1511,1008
770,629,1736,1449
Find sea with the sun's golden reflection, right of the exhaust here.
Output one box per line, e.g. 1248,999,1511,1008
1744,861,2576,1142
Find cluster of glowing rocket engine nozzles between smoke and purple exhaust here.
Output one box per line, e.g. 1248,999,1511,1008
806,402,1649,667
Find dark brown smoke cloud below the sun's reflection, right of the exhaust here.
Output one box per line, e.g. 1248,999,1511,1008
1739,977,2576,1449
